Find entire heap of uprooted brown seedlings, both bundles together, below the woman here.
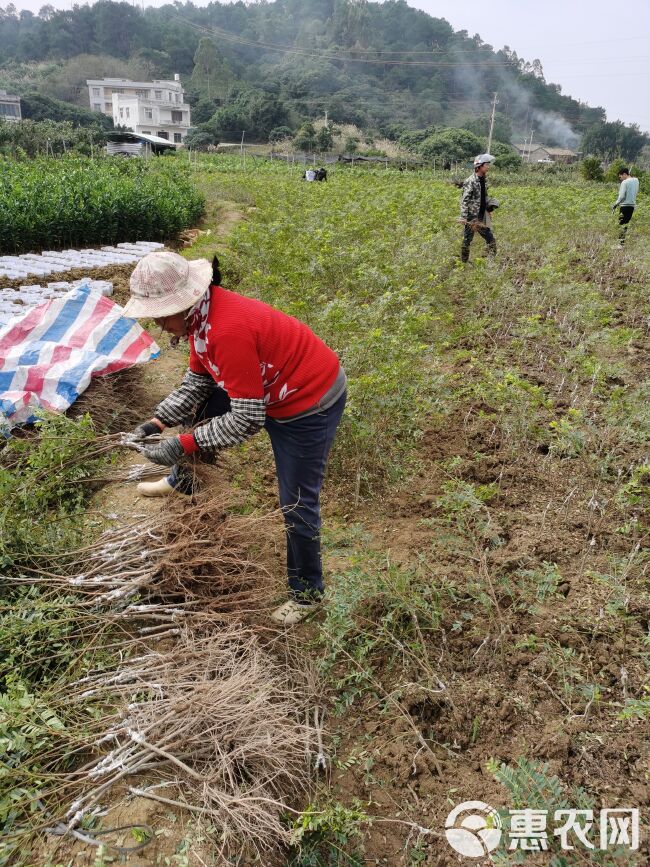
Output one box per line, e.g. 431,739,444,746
15,492,319,864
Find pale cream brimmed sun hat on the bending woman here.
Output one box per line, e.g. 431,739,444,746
124,252,212,319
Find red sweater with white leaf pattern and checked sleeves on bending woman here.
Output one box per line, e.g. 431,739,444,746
156,286,340,451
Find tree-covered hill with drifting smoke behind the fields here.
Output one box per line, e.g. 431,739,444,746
0,0,605,146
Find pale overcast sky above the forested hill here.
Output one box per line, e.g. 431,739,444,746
8,0,650,131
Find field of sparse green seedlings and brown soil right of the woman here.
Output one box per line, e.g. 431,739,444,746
199,161,650,867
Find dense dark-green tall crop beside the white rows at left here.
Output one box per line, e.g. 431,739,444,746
0,156,204,254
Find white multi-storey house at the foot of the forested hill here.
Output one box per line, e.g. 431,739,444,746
86,75,190,144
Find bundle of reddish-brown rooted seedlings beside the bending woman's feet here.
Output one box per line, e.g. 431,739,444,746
17,493,276,624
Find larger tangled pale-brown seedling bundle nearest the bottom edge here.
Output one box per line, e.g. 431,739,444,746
59,624,318,863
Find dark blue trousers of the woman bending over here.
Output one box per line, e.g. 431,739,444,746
169,387,347,602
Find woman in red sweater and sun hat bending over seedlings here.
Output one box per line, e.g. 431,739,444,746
125,252,347,626
